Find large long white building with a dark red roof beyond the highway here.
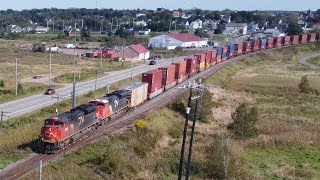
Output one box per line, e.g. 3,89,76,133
148,33,208,48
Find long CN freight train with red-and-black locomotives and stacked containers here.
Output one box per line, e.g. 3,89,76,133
39,34,320,153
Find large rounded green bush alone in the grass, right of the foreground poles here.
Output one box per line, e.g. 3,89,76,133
228,103,259,139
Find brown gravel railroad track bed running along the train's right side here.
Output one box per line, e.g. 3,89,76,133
0,46,304,180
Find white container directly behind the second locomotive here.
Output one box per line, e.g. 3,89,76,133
125,82,148,107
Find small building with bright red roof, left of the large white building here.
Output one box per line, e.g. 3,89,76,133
120,44,150,61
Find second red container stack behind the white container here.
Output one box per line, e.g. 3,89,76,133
159,64,177,90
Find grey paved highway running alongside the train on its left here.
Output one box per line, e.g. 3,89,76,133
0,57,188,121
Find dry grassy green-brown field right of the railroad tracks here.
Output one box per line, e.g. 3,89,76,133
25,45,320,179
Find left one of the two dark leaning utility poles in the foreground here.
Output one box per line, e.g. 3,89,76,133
178,82,192,180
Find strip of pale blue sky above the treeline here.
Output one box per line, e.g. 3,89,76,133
0,0,320,11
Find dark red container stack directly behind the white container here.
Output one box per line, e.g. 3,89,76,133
142,69,164,99
